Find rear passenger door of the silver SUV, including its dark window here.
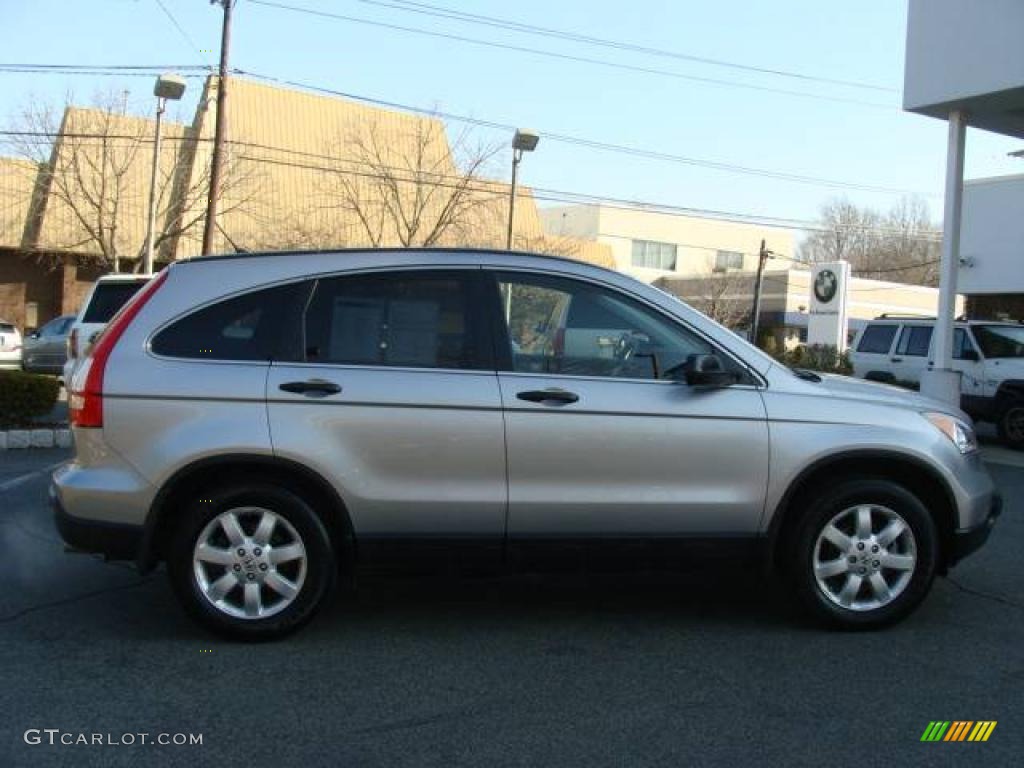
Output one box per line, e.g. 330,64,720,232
266,267,507,556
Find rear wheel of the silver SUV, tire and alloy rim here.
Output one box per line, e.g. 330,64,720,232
167,483,337,640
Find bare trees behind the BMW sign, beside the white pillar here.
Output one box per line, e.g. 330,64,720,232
801,198,941,286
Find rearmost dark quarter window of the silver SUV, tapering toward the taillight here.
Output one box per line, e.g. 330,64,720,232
153,284,309,360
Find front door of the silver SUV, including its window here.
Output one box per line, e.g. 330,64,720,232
493,271,769,543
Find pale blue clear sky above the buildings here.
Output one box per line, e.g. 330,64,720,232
0,0,1024,243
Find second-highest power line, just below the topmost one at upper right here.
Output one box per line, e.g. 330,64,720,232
249,0,897,110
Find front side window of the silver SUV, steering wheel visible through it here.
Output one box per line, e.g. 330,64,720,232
498,274,715,379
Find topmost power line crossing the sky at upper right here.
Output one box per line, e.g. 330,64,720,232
355,0,899,93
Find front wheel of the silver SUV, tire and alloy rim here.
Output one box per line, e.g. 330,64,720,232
792,478,939,630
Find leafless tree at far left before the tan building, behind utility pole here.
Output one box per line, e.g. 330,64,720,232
14,94,254,271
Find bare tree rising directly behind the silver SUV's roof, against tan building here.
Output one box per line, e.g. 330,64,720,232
319,118,502,248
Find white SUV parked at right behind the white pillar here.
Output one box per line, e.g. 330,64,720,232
850,315,1024,449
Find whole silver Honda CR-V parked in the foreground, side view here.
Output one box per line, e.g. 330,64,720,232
51,250,999,638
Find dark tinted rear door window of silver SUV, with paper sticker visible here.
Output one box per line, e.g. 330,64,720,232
305,271,484,369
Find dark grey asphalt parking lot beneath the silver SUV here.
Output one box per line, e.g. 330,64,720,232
0,451,1024,766
